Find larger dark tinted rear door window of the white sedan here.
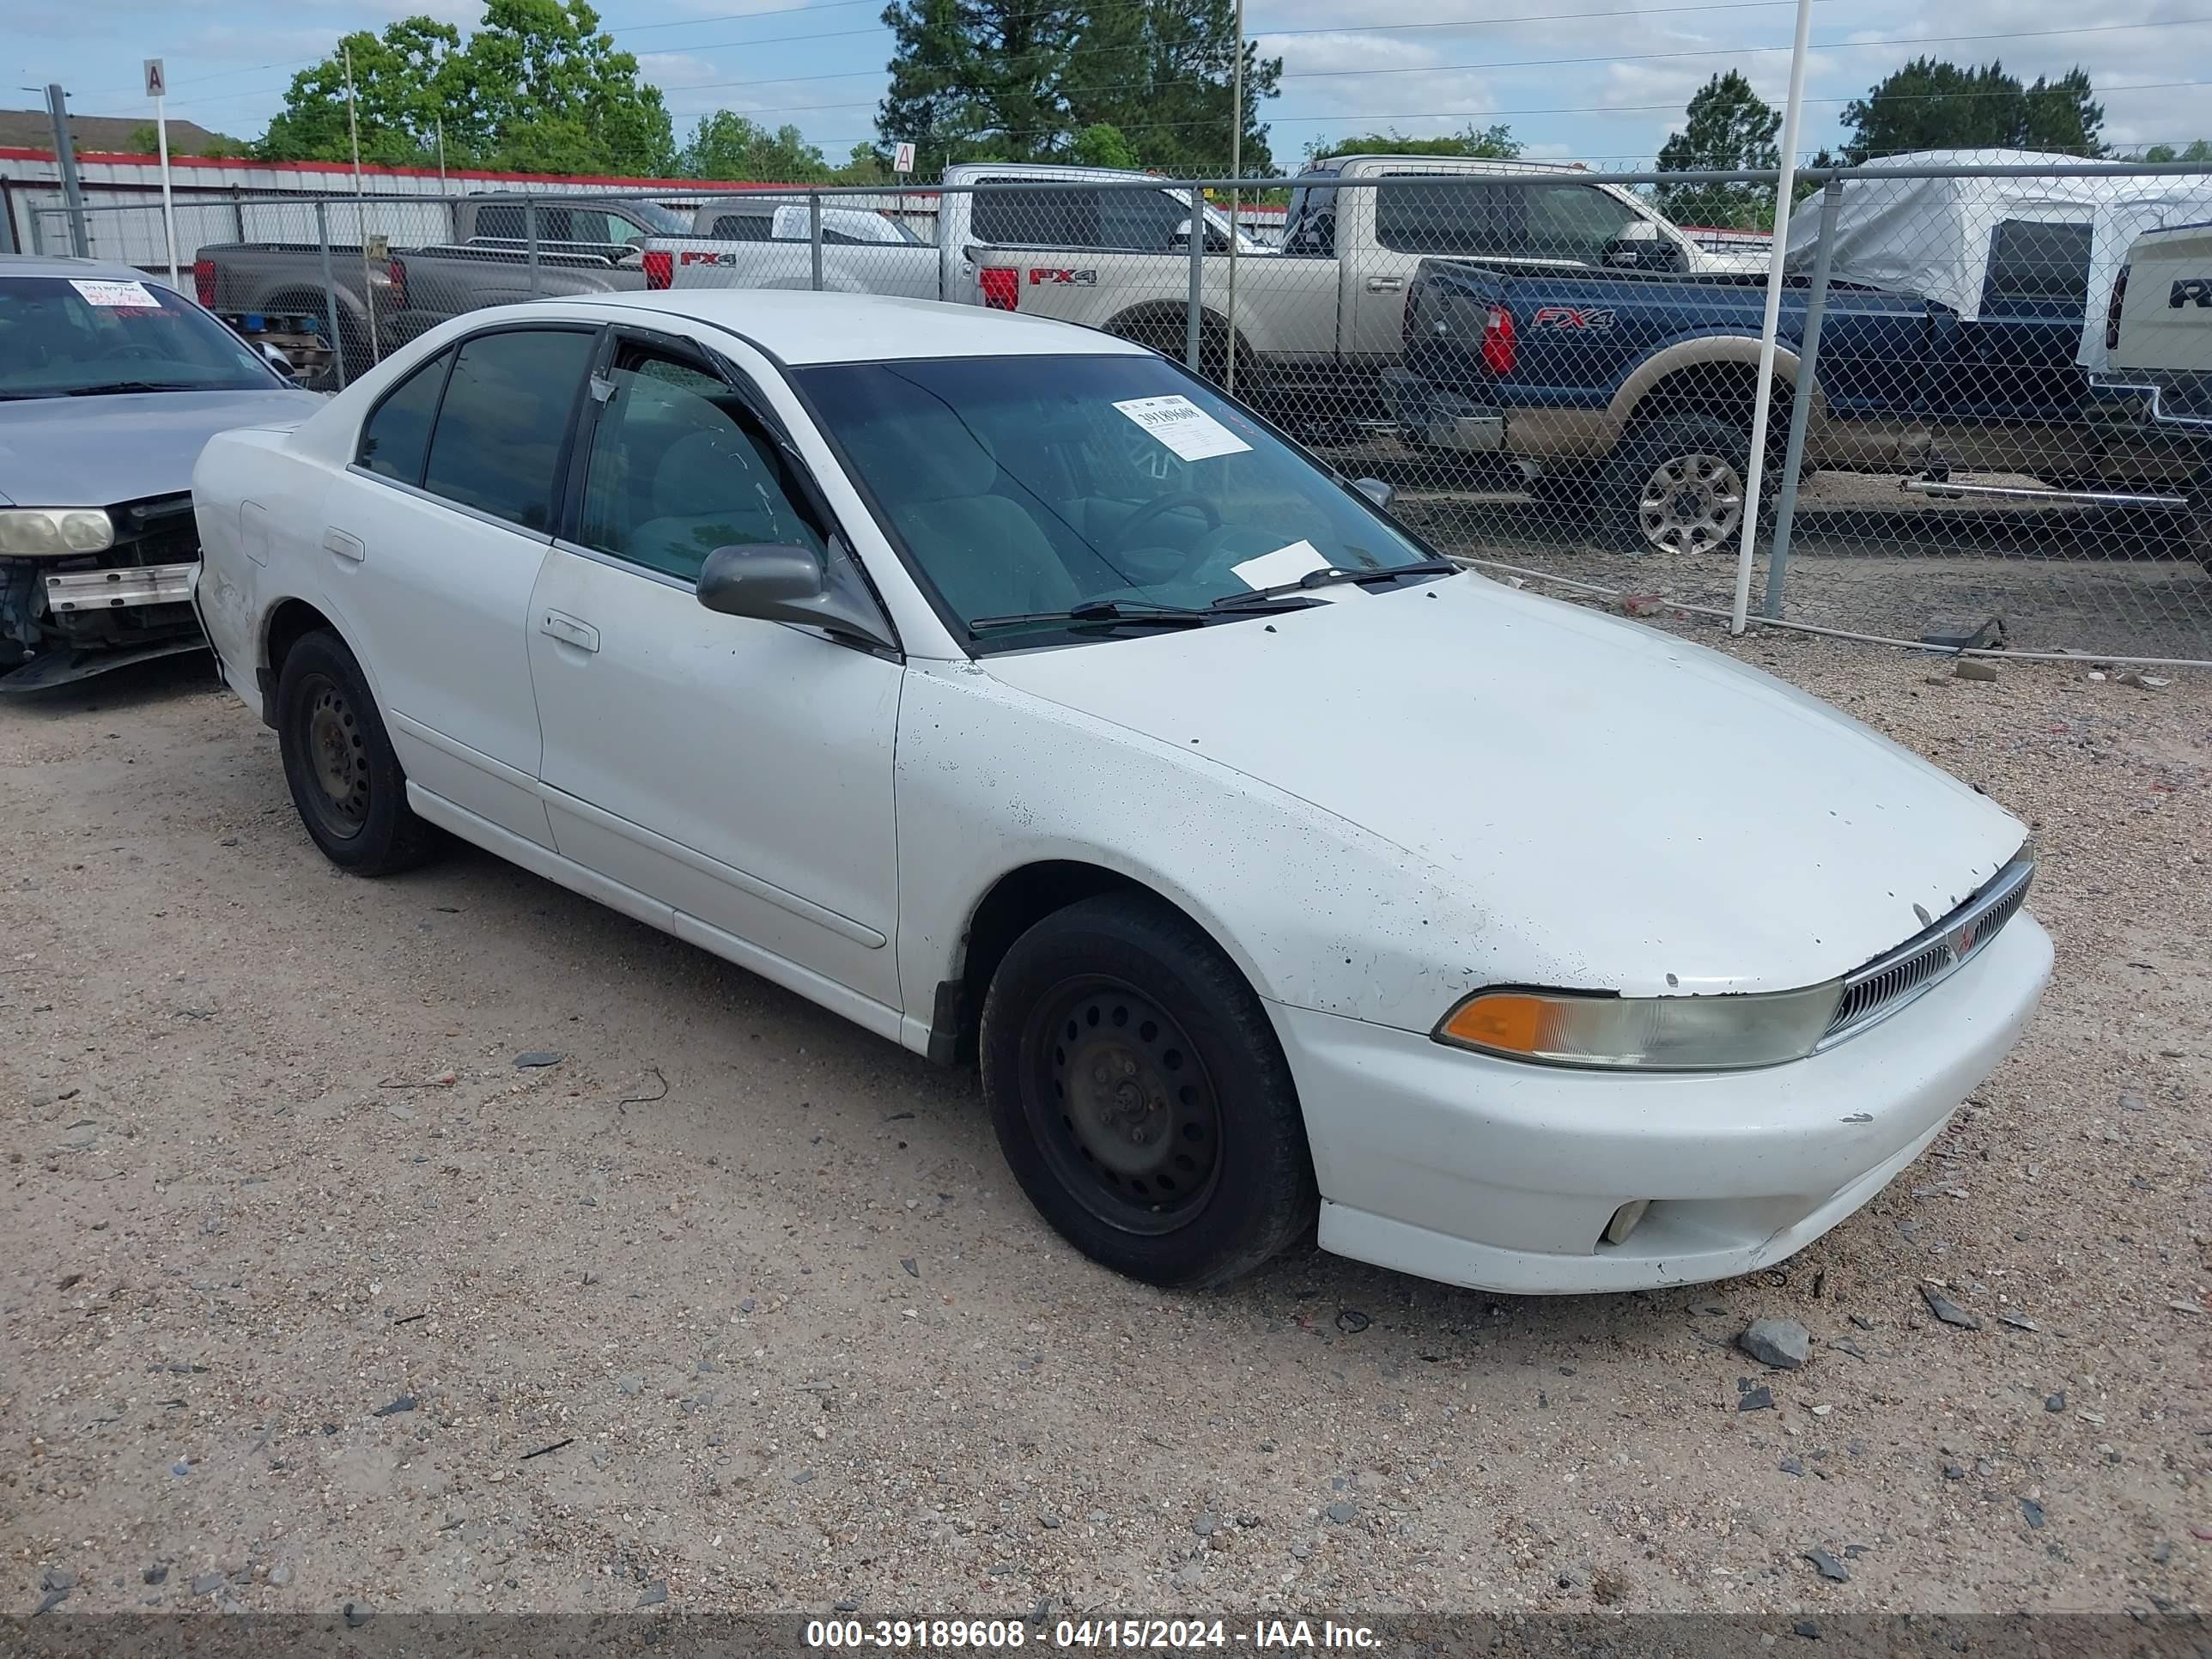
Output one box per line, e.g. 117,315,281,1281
422,330,592,531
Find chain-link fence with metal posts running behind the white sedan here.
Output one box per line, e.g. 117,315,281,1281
42,157,2212,661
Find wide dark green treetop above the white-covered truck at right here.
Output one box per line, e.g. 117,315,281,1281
1843,58,2104,166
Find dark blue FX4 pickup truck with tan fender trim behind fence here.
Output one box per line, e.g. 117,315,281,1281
1385,240,2203,553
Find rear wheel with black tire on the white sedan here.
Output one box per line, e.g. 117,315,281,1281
276,629,438,876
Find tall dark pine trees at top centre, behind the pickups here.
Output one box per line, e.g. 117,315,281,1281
876,0,1283,175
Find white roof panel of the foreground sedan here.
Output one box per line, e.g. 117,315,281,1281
550,288,1144,368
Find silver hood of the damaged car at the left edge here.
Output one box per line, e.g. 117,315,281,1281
0,387,323,507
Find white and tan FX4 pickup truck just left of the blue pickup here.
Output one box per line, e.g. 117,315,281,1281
978,155,1765,410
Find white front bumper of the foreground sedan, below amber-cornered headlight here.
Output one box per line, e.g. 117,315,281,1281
1270,915,2051,1294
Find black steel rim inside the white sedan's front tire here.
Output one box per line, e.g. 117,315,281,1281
1022,975,1221,1237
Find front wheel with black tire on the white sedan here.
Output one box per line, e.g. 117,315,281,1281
980,894,1321,1287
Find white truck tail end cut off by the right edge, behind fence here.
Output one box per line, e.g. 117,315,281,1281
2097,223,2212,568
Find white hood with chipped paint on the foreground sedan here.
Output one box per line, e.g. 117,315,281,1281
984,575,2027,995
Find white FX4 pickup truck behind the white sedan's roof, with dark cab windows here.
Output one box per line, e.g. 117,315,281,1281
639,164,1270,305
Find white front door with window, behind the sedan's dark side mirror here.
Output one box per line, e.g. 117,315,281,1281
529,331,902,1024
